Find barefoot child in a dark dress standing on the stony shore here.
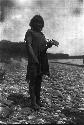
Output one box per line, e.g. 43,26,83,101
25,15,58,110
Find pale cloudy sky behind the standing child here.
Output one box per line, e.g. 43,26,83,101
0,0,84,55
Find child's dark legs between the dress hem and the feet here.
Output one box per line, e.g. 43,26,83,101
29,76,42,105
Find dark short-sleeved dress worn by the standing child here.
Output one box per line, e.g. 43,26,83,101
25,29,49,79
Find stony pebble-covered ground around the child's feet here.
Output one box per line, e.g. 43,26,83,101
0,60,84,124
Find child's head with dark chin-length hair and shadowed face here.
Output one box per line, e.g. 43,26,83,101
29,15,44,32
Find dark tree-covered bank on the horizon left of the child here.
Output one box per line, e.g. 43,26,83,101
0,40,26,57
